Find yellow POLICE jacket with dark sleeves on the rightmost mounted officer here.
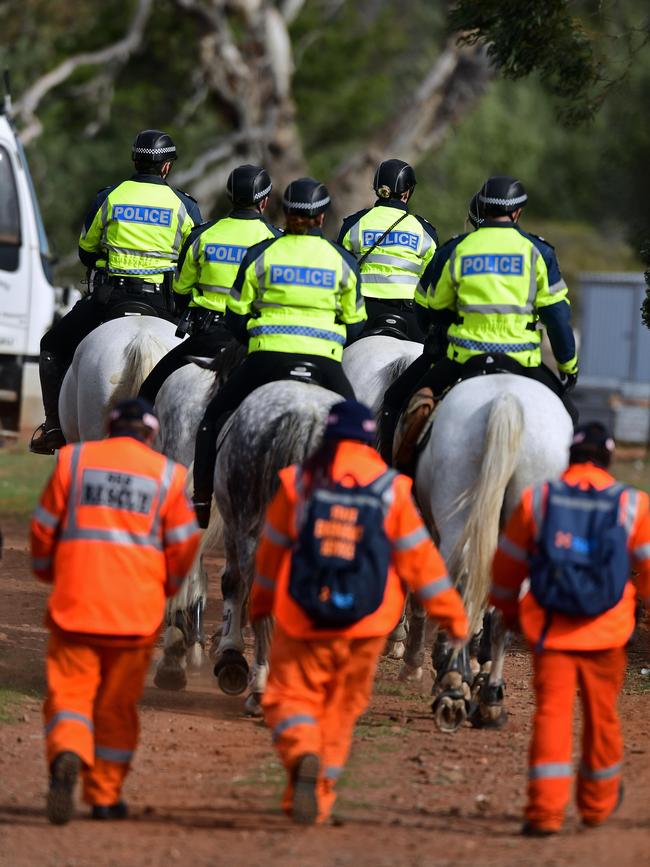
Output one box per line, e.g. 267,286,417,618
416,220,578,373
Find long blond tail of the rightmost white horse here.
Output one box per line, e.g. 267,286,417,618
449,393,524,634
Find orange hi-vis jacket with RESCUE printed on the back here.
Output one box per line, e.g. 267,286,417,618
31,437,200,636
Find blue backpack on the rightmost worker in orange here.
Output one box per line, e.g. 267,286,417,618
530,482,630,617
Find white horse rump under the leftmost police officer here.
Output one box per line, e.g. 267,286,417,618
59,316,179,443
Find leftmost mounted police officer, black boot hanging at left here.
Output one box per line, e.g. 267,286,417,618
30,129,201,454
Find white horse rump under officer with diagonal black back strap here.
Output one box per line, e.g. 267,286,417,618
343,335,422,416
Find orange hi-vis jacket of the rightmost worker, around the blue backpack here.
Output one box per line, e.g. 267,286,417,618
490,463,650,650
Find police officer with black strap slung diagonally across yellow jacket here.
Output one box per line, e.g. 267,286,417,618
338,159,438,341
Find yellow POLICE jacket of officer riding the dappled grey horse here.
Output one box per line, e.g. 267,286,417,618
227,229,366,361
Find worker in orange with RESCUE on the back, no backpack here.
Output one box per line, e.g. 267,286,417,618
31,400,200,825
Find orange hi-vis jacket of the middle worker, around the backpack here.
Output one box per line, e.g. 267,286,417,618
250,440,468,639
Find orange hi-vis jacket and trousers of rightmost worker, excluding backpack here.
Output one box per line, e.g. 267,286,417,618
490,463,650,831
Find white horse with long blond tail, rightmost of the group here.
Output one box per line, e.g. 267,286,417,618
404,374,573,730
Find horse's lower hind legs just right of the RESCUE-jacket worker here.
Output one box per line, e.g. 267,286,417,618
153,558,207,690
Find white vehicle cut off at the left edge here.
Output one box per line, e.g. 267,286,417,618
0,73,56,430
